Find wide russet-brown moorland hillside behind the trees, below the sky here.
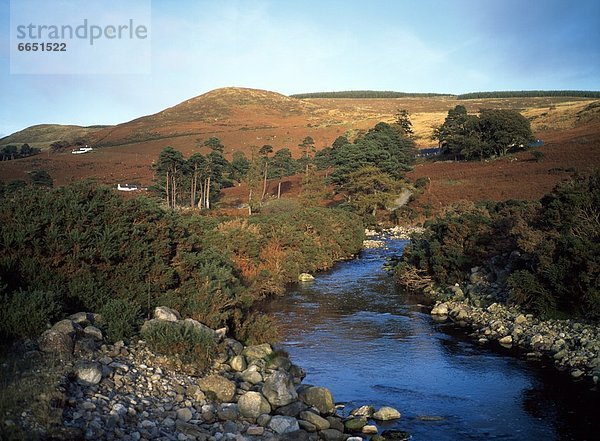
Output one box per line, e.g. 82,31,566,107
0,88,600,201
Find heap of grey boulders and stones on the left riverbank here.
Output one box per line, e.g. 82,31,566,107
2,307,408,441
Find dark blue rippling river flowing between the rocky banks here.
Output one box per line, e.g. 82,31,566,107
266,240,600,441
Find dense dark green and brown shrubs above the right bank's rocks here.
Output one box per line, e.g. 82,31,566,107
396,172,600,320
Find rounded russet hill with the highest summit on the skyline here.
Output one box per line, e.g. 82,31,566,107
89,87,340,153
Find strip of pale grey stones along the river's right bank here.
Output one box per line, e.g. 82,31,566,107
424,268,600,384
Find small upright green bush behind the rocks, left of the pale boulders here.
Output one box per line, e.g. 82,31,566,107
100,299,142,342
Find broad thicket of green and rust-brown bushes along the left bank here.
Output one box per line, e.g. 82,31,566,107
0,182,364,341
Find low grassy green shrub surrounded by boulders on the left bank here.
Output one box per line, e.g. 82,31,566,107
141,321,216,370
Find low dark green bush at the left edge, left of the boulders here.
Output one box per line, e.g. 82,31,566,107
0,290,62,338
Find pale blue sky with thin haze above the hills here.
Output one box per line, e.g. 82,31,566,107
0,0,600,135
